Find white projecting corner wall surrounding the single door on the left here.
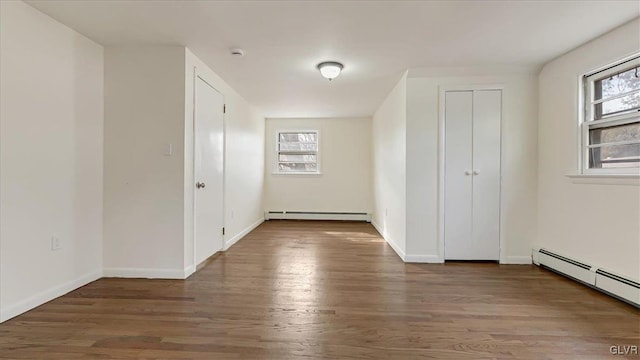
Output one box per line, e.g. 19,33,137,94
104,46,264,278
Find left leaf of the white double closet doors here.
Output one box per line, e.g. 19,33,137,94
444,91,473,260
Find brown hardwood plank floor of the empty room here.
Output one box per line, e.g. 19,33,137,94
0,221,640,360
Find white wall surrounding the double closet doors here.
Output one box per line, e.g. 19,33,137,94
406,68,537,263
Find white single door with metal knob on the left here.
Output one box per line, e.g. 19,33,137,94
194,76,224,266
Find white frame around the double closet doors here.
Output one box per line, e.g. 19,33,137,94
437,84,507,264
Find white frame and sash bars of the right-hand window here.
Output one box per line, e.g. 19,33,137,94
579,53,640,176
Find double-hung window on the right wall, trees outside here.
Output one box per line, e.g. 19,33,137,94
582,56,640,174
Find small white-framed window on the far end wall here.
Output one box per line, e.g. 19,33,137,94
276,130,319,173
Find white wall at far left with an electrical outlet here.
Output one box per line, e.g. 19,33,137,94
0,1,103,321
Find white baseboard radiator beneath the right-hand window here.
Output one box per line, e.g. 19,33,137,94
533,249,640,308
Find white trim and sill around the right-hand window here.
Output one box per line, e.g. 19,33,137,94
567,53,640,177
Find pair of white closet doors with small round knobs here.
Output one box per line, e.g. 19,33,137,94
443,90,502,260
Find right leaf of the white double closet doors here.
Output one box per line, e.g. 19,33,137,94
469,90,502,260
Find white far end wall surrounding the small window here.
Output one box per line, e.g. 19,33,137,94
265,118,372,213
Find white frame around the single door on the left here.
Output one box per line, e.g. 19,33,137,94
189,66,227,272
